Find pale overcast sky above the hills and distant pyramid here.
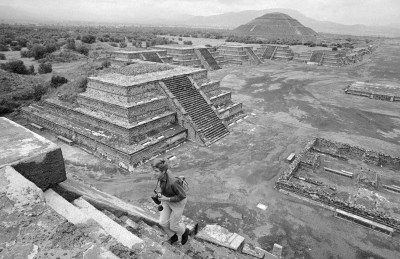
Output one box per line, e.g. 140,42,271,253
0,0,400,25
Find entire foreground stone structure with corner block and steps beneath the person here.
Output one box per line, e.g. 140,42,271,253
0,118,282,259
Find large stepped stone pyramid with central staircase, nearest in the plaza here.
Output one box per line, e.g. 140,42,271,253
23,60,243,170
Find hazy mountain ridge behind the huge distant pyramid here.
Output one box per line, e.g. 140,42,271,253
181,8,400,37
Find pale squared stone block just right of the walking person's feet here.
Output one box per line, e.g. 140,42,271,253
196,225,244,251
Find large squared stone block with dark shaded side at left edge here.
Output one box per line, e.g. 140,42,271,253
0,118,67,190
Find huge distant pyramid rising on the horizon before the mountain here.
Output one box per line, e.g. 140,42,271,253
234,13,317,42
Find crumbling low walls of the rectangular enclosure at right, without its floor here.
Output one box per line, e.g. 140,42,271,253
275,138,400,235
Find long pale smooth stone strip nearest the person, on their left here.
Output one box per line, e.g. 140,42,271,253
72,197,143,248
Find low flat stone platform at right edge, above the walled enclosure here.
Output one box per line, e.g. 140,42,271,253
344,82,400,102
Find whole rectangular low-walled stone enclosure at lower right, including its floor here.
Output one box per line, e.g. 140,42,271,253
275,138,400,235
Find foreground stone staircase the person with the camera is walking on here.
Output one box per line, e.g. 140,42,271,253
44,178,282,259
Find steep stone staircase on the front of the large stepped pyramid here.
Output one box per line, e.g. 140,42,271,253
162,76,229,144
